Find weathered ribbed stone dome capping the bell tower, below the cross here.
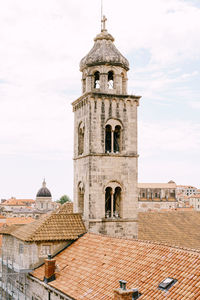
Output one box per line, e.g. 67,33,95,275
80,29,129,71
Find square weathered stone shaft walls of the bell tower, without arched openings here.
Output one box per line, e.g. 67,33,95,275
74,94,138,236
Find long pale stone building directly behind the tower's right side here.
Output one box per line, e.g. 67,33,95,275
138,181,178,211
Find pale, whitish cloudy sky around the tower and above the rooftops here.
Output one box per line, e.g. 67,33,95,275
0,0,200,200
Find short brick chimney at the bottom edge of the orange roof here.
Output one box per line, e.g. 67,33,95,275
113,280,141,300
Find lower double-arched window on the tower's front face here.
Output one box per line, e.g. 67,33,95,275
105,183,122,219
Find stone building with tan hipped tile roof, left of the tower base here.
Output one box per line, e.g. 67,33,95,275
0,204,86,300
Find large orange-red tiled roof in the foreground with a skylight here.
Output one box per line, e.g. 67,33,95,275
33,233,200,300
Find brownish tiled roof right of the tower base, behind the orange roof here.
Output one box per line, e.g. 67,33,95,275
138,211,200,250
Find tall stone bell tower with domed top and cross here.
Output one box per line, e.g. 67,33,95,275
72,17,140,237
